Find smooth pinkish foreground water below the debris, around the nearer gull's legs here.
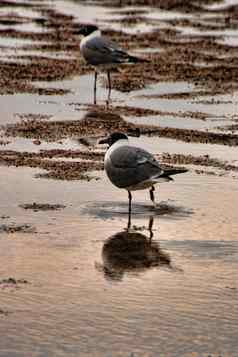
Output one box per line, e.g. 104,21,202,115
0,168,238,356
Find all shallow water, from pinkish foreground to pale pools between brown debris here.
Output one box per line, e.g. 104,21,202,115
0,1,238,357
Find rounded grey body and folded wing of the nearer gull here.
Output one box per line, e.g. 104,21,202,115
105,146,163,188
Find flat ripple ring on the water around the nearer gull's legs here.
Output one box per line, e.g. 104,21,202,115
81,201,193,220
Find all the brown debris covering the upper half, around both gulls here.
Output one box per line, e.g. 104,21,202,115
0,0,238,180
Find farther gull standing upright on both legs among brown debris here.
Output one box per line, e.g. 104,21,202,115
73,24,148,104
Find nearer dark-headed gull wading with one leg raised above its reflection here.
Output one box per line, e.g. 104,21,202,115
98,132,188,214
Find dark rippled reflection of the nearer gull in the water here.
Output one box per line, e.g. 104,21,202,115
100,216,171,281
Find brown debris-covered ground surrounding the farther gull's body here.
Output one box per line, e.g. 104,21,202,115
0,0,238,95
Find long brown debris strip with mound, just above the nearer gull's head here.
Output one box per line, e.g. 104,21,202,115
5,107,238,146
